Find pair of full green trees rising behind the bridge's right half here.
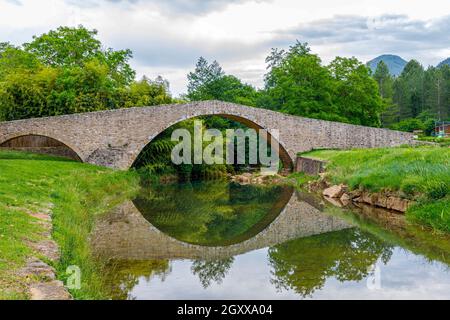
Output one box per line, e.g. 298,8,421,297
257,41,384,126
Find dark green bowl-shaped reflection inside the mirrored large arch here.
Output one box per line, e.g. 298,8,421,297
133,181,293,246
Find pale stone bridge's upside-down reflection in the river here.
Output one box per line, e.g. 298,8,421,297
91,191,352,260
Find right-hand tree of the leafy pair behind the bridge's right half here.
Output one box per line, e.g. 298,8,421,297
328,57,384,127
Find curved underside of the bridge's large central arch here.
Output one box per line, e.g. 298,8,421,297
127,112,294,172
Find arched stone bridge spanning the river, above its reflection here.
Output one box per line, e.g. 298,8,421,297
0,101,413,169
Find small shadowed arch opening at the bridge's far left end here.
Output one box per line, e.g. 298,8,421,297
0,133,83,162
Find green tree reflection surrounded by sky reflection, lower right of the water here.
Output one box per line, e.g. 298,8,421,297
269,228,393,297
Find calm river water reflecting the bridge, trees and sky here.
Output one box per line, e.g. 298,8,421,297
92,182,450,299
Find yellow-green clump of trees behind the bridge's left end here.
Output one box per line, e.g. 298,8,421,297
0,26,172,120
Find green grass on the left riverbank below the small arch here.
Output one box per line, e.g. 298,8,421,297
0,151,138,299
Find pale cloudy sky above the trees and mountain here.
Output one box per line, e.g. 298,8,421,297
0,0,450,95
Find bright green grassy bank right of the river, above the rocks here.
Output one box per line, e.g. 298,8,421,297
302,146,450,232
